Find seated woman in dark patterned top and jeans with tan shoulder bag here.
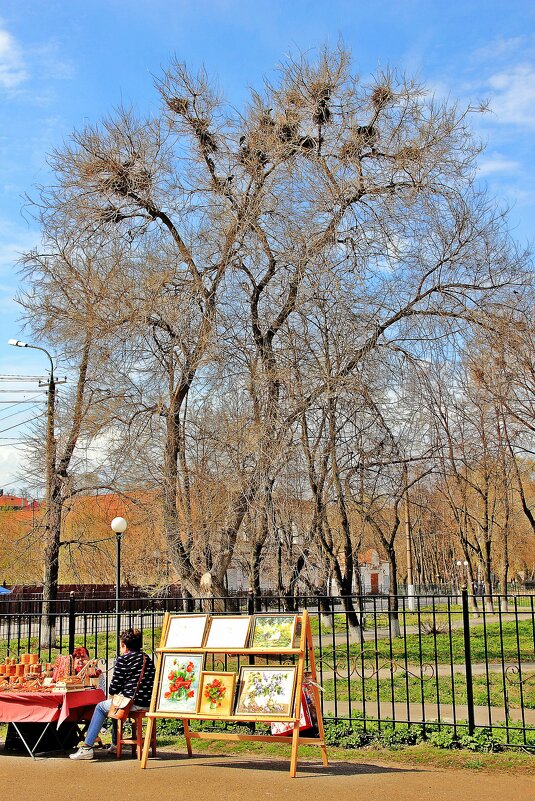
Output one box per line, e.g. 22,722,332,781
70,629,155,759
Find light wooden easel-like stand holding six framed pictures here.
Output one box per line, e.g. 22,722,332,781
140,610,329,778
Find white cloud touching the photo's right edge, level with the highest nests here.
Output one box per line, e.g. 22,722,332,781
487,62,535,128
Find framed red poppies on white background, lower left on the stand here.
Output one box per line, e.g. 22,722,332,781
155,654,204,715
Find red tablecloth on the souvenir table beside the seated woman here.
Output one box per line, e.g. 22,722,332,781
0,689,106,728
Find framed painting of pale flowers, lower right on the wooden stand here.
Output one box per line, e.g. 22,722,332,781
234,665,297,720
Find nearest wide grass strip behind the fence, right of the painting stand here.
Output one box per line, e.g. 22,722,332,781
322,673,535,709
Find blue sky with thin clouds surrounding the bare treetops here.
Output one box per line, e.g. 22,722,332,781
0,0,535,487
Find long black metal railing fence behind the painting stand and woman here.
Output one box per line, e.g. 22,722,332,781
0,590,535,748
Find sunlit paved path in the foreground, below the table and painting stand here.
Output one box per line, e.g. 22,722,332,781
0,753,535,801
